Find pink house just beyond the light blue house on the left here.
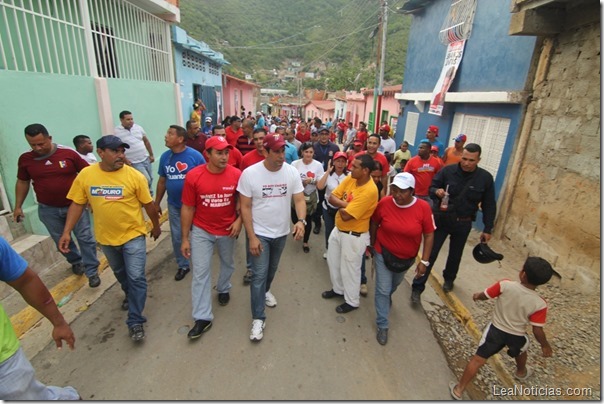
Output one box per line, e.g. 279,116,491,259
221,74,260,119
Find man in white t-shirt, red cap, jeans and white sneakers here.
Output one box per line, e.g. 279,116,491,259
237,134,306,341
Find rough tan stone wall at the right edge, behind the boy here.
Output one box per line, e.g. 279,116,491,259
500,16,600,291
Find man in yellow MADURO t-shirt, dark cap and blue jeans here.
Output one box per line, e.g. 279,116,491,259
59,135,161,341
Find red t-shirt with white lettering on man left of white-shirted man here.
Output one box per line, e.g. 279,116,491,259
182,164,241,236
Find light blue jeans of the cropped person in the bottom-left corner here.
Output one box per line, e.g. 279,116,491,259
0,348,80,401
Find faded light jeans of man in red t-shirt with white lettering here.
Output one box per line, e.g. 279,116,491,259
191,225,236,321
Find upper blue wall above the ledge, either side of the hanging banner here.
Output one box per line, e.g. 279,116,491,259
403,0,536,93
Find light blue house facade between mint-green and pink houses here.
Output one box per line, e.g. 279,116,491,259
172,26,228,126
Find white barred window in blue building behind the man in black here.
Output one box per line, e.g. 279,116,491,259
451,114,511,179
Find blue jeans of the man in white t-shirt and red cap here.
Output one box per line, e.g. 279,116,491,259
250,235,287,320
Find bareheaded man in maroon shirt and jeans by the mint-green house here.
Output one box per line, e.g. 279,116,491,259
13,123,101,288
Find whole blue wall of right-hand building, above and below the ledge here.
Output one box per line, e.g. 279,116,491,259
395,0,536,223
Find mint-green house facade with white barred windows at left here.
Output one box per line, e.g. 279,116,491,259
0,0,181,237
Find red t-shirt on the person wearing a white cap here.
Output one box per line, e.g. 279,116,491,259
372,196,436,259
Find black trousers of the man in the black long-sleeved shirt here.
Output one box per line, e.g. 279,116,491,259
412,214,472,293
